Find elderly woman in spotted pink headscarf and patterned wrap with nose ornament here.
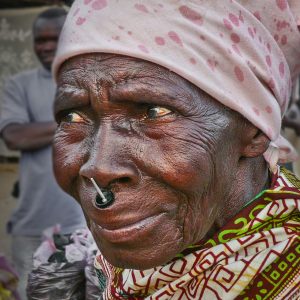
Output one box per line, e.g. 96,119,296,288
54,0,300,299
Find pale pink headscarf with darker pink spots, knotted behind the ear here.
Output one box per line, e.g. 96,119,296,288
53,0,300,170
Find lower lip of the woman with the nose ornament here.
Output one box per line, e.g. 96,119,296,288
91,213,165,243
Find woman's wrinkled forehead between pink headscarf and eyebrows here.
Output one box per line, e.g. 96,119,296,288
59,53,203,109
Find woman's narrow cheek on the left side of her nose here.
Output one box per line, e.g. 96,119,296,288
53,128,88,196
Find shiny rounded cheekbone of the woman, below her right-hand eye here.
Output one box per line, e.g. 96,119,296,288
143,120,214,193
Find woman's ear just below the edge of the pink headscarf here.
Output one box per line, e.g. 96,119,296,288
241,124,270,158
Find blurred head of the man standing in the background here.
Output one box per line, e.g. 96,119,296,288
32,7,67,70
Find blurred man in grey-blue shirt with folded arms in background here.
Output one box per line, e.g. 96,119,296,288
0,8,85,299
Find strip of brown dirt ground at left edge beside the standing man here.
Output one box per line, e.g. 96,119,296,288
0,163,18,258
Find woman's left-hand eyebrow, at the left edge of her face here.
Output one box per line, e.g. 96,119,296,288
54,86,90,114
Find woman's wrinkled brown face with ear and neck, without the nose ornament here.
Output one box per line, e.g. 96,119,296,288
54,54,268,269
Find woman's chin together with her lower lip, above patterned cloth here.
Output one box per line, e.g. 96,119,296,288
86,206,189,270
